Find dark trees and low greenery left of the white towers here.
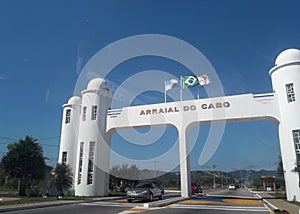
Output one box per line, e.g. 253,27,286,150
0,135,73,199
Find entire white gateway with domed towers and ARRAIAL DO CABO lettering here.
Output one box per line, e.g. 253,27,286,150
59,46,300,201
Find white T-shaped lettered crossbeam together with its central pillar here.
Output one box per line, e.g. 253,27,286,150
107,94,279,197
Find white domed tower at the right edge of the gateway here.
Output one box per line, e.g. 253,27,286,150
269,49,300,201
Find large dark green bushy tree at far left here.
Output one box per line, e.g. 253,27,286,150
1,135,46,196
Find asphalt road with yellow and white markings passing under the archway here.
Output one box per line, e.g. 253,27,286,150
0,189,270,214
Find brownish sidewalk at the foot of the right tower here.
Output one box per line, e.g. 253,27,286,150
256,192,300,214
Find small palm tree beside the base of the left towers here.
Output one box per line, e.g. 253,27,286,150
51,163,73,196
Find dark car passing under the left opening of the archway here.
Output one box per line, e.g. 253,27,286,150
126,181,164,202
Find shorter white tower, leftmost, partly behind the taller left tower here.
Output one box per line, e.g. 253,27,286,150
58,96,81,174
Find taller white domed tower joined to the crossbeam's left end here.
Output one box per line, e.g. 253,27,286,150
75,78,113,196
